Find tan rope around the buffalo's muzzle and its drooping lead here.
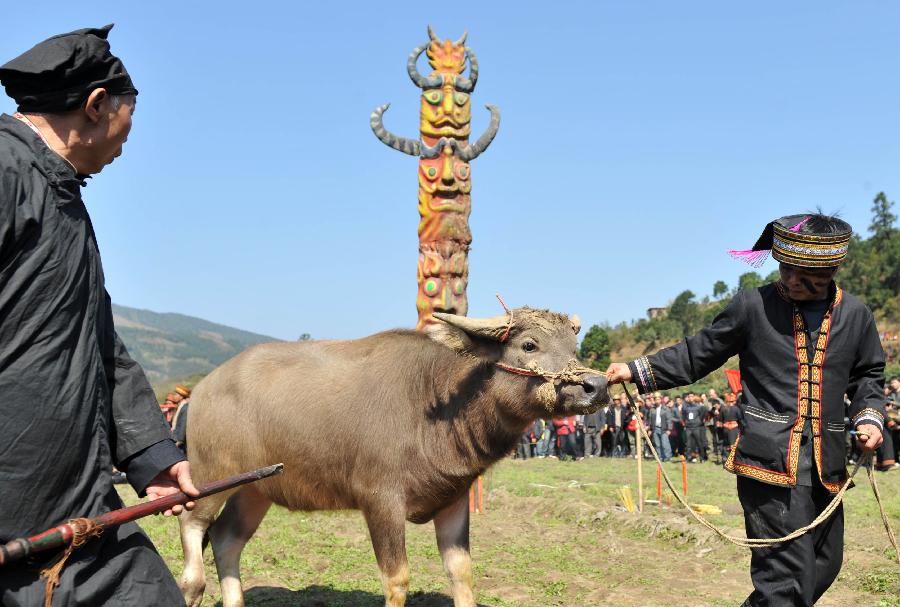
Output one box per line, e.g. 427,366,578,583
497,359,900,564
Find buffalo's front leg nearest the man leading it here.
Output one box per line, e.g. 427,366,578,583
434,492,475,607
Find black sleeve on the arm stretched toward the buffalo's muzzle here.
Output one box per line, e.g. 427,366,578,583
628,291,746,394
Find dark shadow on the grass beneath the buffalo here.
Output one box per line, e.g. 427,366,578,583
216,586,491,607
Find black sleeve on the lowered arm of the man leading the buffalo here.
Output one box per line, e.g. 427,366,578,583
847,310,885,431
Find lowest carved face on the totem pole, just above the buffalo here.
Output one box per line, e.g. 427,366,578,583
416,242,469,329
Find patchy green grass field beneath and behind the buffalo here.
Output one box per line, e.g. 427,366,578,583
121,459,900,607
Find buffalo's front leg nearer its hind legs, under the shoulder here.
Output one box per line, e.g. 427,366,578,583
363,502,409,607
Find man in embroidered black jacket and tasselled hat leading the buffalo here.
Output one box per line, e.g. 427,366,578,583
607,214,884,607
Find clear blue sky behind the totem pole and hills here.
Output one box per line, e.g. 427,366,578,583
0,1,900,339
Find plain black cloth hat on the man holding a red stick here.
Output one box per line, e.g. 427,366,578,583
0,24,137,113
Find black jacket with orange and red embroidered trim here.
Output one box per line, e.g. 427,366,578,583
629,283,884,492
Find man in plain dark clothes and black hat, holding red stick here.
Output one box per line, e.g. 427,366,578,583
0,26,196,607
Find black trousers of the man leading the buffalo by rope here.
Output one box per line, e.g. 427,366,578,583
737,478,844,607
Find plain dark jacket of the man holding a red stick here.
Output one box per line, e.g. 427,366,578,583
0,115,184,541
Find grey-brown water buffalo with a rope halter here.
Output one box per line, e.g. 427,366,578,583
180,308,609,607
